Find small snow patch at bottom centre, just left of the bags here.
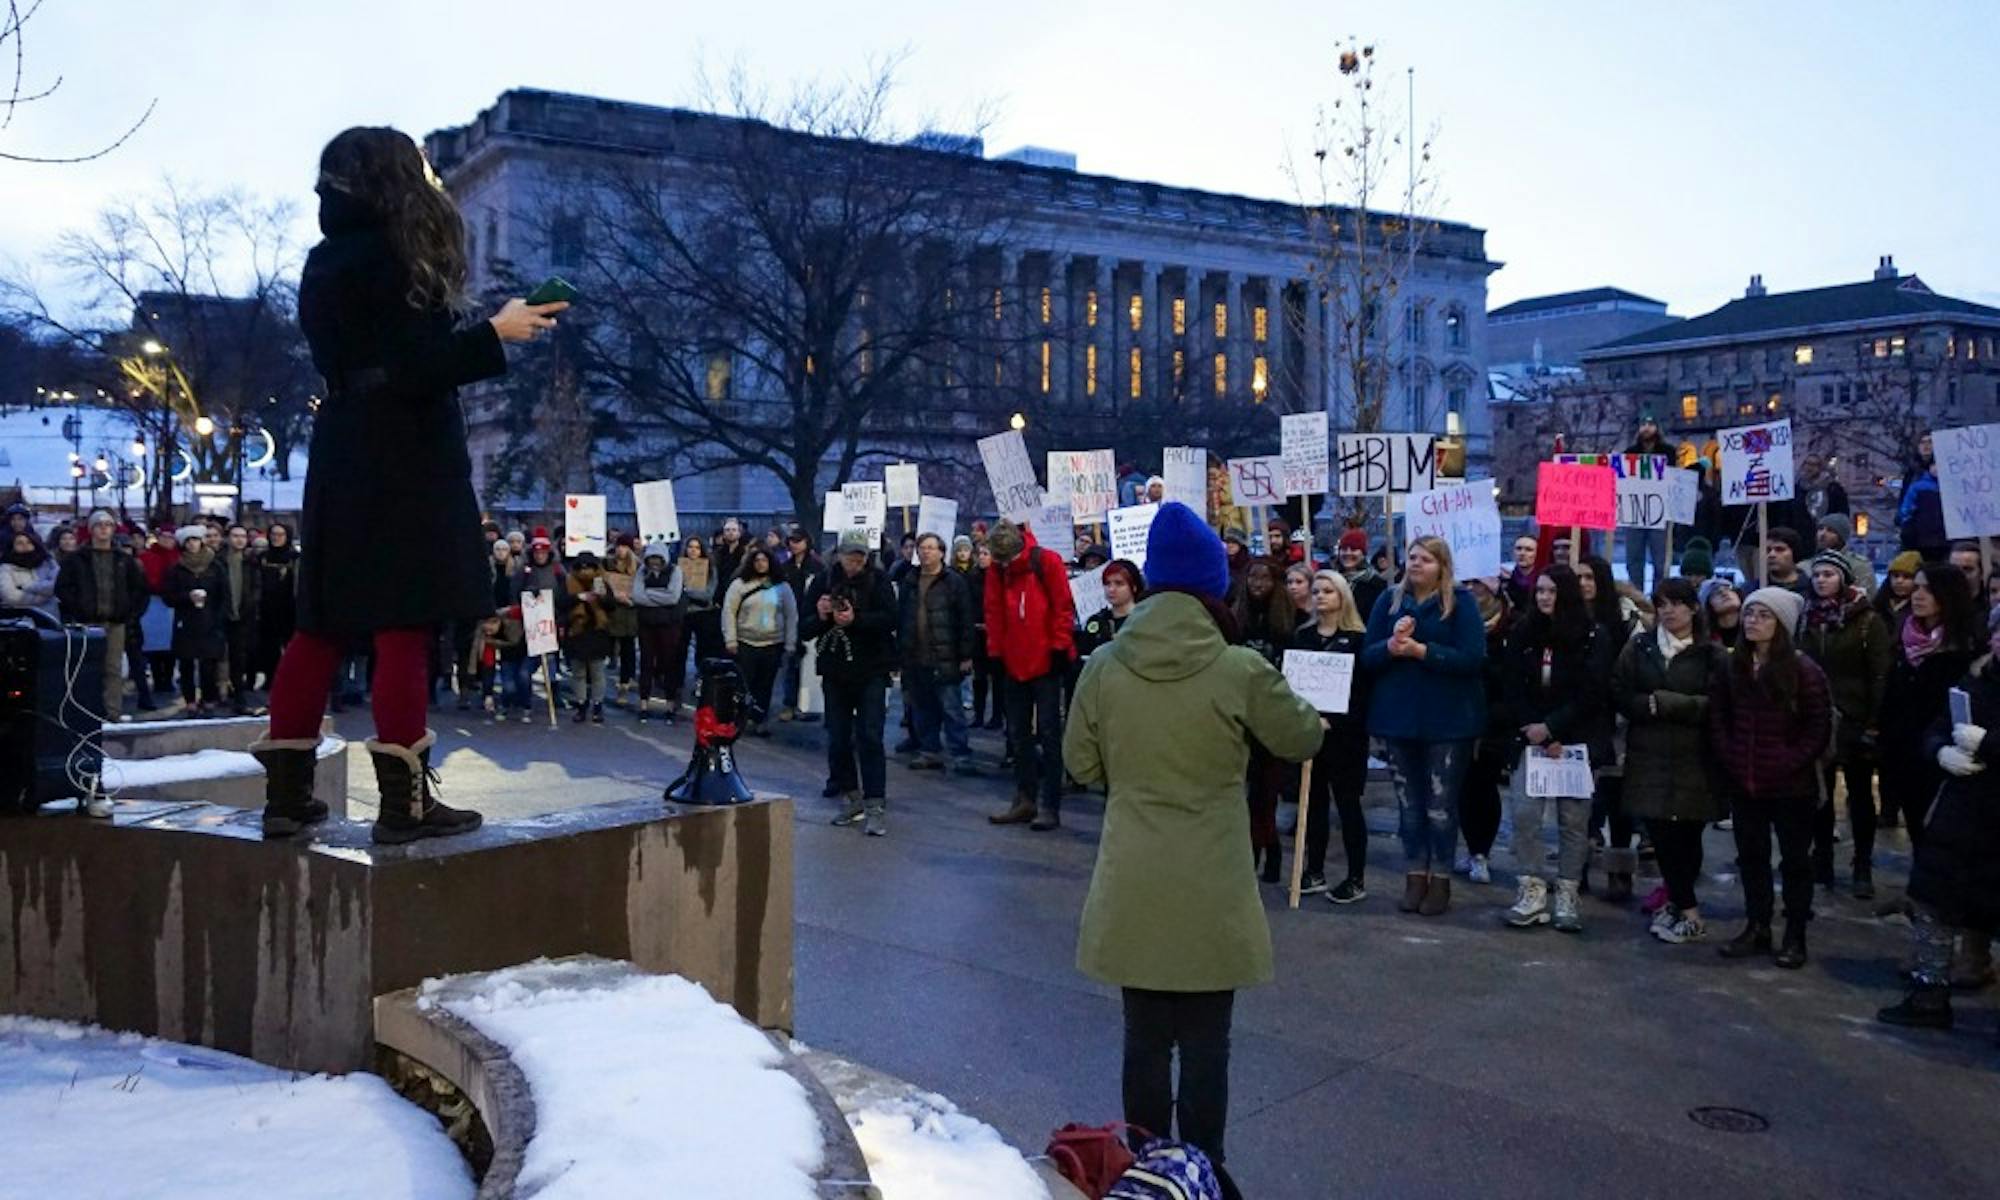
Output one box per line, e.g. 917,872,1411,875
848,1092,1048,1200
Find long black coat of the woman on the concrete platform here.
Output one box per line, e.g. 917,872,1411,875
298,192,506,636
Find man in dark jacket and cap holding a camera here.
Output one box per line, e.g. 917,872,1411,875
798,530,898,838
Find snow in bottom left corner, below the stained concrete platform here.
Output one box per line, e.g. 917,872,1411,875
0,1016,472,1200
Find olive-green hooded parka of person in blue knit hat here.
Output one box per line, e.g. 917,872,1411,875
1062,592,1320,992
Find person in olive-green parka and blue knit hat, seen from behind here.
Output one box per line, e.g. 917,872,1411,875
1062,502,1322,1188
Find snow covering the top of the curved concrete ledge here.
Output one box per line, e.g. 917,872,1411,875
420,962,824,1200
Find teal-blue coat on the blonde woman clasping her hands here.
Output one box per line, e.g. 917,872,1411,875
1362,588,1486,742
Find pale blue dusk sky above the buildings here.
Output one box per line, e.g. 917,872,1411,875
0,0,2000,314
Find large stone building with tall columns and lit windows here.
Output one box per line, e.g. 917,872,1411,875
426,90,1498,516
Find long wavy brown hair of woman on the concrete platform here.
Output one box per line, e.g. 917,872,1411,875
318,126,466,308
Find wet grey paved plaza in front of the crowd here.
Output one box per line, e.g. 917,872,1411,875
338,710,2000,1200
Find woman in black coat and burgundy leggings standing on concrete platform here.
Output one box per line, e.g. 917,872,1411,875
252,128,566,842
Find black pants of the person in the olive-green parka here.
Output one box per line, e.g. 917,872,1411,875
1124,988,1236,1164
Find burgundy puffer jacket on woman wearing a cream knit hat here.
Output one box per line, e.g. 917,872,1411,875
1708,650,1832,800
